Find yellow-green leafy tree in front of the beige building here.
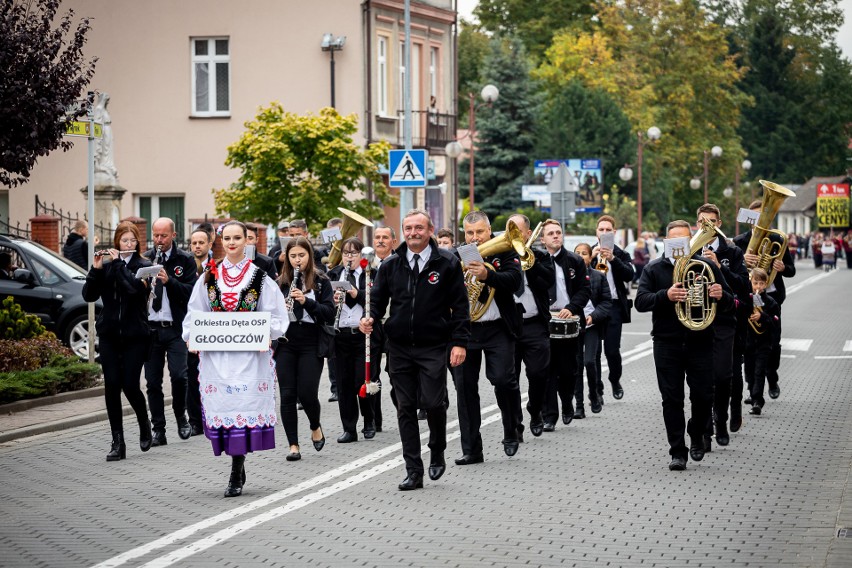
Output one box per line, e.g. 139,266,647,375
214,102,396,231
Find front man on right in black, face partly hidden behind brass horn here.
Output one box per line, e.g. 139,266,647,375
636,220,734,471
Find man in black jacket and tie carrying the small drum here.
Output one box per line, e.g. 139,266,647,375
541,219,592,432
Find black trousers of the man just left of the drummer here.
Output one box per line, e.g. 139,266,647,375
515,317,550,423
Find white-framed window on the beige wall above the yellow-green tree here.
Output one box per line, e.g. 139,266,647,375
190,38,231,116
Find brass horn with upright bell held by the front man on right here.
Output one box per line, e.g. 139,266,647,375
672,220,726,331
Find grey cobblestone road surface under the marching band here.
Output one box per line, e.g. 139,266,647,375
0,264,852,567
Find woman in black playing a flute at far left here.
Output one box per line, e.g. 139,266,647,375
83,222,152,461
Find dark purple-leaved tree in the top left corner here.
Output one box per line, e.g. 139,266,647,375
0,0,97,187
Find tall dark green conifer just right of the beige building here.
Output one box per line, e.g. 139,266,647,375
459,39,538,219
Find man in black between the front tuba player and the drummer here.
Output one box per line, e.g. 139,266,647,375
509,214,556,436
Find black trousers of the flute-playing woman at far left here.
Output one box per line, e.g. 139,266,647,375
100,335,149,432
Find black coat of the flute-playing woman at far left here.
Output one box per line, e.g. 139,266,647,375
83,253,153,339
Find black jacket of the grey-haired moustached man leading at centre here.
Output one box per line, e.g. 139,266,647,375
370,239,470,348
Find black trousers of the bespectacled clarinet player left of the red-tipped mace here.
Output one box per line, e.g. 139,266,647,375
334,328,373,434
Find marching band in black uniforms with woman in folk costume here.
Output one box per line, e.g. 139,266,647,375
96,182,795,497
